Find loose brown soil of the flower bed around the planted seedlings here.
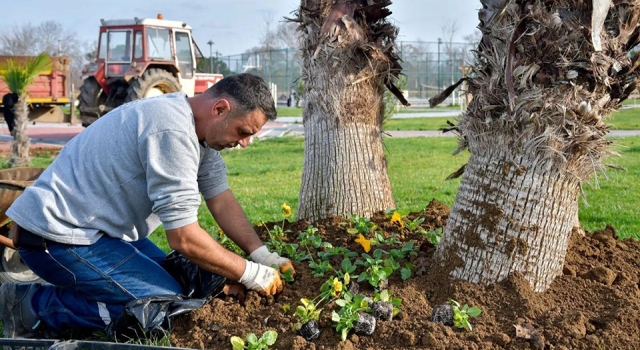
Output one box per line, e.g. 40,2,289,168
171,200,640,349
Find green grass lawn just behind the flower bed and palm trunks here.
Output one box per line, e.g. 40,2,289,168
6,137,640,250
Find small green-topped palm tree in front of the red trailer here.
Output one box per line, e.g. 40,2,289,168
0,53,51,167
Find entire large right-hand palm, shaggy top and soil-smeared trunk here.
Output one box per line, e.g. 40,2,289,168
431,0,640,292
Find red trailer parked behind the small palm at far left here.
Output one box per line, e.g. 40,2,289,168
0,56,71,122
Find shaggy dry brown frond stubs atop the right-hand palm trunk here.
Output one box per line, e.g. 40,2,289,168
442,0,640,180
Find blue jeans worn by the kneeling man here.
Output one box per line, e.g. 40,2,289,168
20,235,182,332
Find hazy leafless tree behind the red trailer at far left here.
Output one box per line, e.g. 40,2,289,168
0,21,91,86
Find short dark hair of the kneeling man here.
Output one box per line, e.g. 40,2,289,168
204,73,277,120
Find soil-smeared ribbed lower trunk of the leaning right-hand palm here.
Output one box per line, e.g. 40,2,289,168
437,144,580,292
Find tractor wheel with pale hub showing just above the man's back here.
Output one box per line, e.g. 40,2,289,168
126,68,182,102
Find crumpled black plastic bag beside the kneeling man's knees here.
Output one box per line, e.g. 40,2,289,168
106,251,226,341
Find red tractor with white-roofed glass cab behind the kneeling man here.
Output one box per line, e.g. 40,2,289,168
78,15,222,126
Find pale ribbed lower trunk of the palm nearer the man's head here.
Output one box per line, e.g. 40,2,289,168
298,67,395,222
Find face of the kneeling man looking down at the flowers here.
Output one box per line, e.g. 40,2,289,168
206,106,267,151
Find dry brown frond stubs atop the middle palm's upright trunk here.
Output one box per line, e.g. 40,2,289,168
294,0,409,126
